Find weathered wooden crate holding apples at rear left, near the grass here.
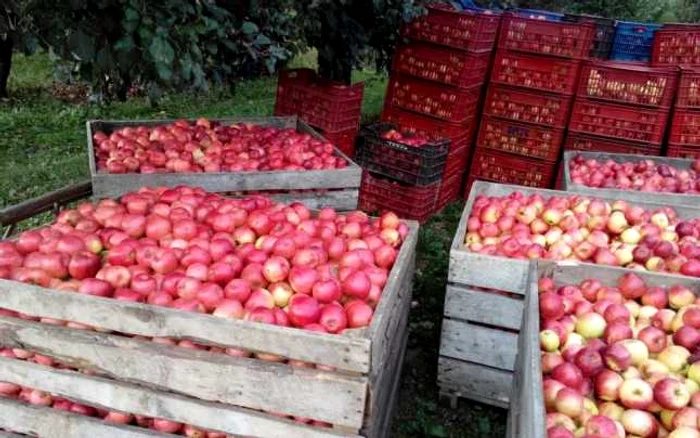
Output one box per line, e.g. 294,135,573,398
87,117,362,211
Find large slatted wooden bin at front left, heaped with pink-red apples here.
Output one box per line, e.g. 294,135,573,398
0,187,418,438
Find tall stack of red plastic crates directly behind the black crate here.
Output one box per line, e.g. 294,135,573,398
382,3,501,211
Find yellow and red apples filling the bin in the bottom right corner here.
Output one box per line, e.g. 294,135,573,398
539,273,700,438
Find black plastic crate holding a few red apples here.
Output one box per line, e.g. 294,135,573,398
355,123,450,185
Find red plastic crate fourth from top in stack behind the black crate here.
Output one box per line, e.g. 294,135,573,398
382,105,476,144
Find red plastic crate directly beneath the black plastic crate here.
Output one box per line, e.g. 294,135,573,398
359,172,440,222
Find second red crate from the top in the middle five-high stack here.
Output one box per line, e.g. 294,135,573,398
491,50,581,94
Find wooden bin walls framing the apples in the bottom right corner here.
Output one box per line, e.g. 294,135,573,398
506,262,700,438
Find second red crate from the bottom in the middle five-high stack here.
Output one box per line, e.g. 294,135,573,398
476,117,564,161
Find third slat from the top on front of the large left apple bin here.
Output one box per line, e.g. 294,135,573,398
0,358,360,438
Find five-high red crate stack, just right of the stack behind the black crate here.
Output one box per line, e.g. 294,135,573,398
465,10,595,193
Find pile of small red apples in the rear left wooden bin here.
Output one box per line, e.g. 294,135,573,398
92,119,348,173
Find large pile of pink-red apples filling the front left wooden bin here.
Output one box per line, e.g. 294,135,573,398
0,187,408,343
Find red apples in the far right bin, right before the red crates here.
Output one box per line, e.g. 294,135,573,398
569,155,700,194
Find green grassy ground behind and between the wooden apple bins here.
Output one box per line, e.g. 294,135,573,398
0,55,505,438
